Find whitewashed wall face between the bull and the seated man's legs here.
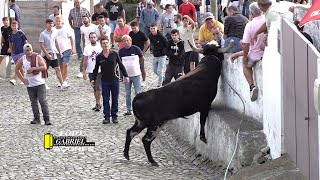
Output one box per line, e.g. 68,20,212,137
214,53,263,123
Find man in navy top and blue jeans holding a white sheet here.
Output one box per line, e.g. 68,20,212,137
119,35,144,116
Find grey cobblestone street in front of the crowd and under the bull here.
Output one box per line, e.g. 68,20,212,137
0,51,223,180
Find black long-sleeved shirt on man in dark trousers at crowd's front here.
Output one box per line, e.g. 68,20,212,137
92,50,128,82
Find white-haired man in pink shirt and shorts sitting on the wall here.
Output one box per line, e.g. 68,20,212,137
230,2,266,101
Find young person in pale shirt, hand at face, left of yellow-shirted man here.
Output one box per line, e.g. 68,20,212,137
178,15,196,74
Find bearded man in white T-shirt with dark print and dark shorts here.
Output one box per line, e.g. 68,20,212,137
82,32,102,111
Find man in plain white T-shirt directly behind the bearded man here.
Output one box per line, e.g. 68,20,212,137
77,16,96,78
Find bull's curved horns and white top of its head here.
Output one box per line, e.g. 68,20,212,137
188,40,234,55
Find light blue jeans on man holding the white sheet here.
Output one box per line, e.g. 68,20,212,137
124,75,141,111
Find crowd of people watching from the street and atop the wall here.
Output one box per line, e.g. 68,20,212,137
1,0,312,125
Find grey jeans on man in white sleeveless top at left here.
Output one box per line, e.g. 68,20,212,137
27,84,49,121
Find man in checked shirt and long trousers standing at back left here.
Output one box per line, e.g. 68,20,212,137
68,0,91,78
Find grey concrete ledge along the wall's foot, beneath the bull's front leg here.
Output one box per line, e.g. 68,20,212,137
172,106,267,173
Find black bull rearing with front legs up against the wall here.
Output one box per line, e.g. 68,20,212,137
124,40,231,166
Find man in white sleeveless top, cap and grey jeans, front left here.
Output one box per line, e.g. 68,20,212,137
15,44,51,125
